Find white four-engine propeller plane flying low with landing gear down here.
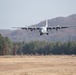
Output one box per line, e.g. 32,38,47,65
13,20,74,35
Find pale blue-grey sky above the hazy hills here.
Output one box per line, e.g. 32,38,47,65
0,0,76,29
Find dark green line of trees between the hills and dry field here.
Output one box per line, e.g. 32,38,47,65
0,34,76,55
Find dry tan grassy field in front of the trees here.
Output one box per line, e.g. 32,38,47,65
0,55,76,75
